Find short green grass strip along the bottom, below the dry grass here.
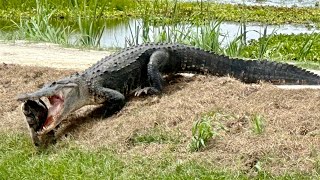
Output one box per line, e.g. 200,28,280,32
0,132,317,179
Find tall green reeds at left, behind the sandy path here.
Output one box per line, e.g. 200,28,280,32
10,0,105,48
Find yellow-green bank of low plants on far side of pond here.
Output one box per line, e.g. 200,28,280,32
0,0,320,25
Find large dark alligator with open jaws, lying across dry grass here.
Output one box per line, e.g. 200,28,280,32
17,43,320,145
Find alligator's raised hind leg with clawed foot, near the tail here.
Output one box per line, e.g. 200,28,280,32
135,49,169,96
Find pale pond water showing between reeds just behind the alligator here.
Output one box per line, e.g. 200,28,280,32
100,19,320,48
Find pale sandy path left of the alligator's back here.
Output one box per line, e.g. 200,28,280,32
0,41,110,70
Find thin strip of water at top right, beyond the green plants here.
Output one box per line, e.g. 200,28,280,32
184,0,319,7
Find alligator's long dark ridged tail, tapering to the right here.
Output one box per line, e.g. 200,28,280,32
182,53,320,85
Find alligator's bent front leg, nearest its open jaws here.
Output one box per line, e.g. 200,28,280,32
95,87,125,116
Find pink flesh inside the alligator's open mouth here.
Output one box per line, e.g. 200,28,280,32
42,95,64,128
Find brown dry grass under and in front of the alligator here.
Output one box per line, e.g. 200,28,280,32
0,65,320,174
